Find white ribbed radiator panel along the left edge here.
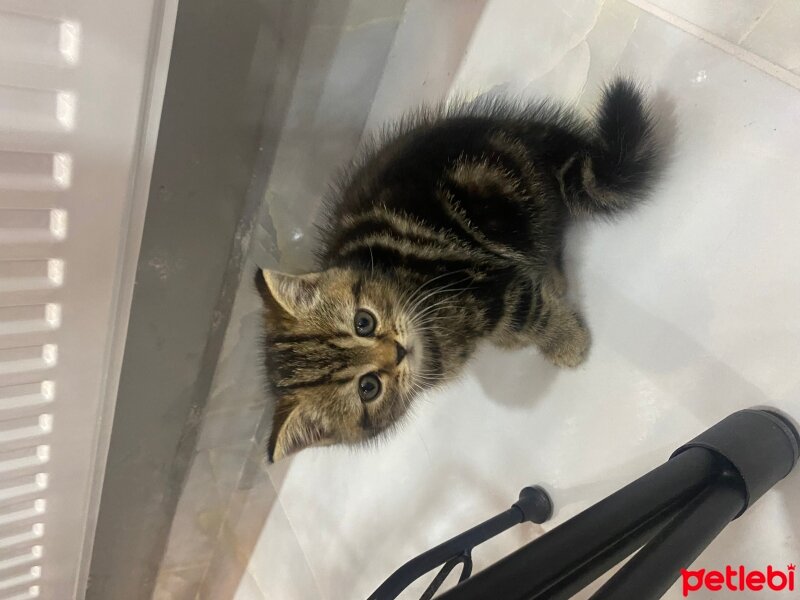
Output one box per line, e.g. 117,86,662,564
0,0,173,600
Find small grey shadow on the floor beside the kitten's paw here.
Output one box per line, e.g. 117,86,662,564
469,345,559,408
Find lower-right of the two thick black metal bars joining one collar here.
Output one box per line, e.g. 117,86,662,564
591,469,747,600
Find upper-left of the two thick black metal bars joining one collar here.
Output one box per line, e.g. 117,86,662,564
441,448,720,600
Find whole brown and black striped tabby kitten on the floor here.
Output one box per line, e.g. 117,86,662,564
256,79,659,461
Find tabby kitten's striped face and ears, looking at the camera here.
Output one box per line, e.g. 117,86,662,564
256,269,430,461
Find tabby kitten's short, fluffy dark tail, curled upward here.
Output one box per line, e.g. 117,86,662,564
561,79,661,215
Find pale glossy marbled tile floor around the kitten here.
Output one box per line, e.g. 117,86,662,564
153,0,800,600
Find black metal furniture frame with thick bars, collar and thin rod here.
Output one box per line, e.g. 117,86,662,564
370,409,800,600
